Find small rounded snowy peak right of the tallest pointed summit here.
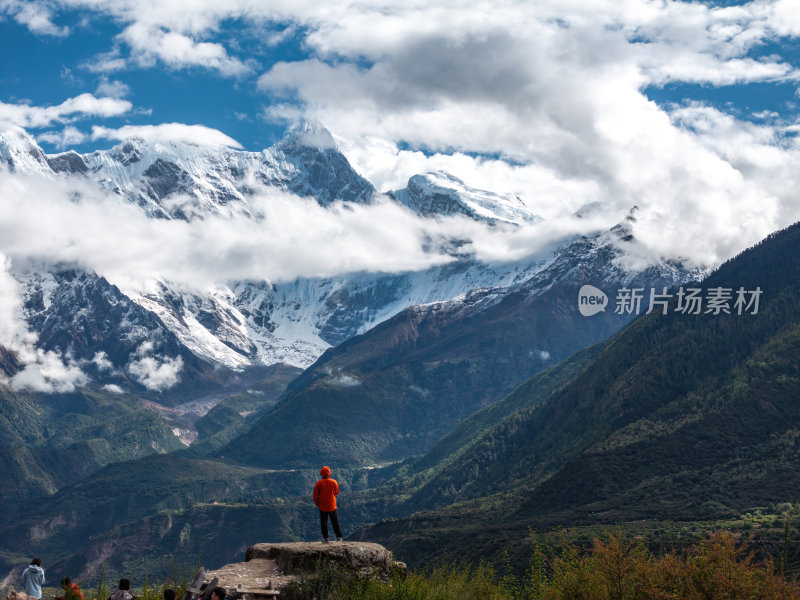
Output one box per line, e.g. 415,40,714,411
389,171,541,225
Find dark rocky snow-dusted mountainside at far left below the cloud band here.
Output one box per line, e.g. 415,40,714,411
15,269,280,401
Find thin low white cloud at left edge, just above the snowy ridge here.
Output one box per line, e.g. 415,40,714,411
0,94,132,129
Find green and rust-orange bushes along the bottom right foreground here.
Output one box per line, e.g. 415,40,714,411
281,533,800,600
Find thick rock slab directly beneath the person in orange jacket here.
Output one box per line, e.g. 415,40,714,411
245,542,405,577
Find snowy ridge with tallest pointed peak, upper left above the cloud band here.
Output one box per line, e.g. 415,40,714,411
0,122,375,220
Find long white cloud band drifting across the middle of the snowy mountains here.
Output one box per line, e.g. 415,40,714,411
0,173,485,291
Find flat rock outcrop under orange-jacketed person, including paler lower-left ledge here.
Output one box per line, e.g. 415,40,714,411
206,542,406,600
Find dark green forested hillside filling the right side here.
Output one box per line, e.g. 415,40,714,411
360,226,800,560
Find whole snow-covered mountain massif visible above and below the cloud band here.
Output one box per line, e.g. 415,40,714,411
0,122,704,398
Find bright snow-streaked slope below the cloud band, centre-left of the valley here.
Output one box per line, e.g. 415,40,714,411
132,261,537,369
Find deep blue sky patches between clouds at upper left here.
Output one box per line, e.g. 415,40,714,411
0,12,307,152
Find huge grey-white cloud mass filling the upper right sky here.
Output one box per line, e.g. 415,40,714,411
247,2,797,241
